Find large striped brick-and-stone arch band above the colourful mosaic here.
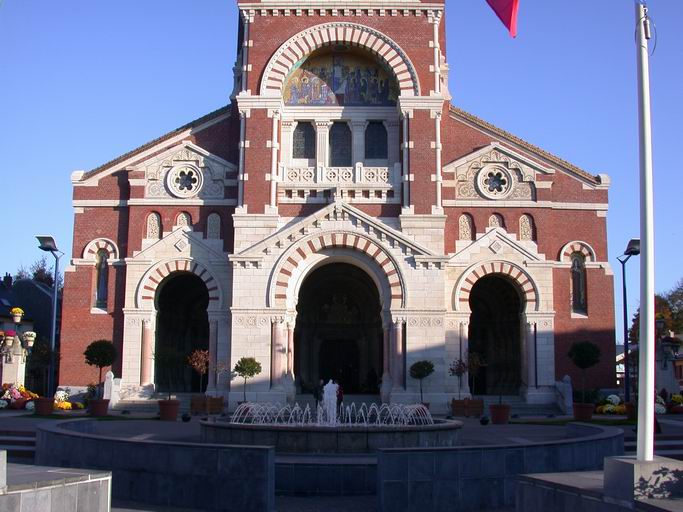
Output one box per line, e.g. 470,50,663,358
260,22,420,96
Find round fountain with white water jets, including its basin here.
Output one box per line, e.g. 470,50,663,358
201,398,462,453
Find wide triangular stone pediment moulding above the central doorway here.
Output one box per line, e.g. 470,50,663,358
234,200,436,259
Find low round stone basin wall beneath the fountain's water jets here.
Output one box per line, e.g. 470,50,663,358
200,419,462,453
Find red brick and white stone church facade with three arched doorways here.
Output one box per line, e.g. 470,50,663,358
59,0,615,410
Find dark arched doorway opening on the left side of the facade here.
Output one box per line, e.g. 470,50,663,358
154,272,209,393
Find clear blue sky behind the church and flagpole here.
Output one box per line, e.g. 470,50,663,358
0,0,683,339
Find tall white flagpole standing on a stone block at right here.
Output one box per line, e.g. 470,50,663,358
635,2,655,461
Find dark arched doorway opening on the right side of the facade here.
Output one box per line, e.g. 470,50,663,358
469,274,522,395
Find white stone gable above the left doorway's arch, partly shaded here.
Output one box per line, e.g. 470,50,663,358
133,226,227,261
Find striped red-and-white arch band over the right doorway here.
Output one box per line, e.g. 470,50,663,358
453,261,540,313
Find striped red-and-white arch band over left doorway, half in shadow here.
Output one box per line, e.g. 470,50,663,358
136,258,223,311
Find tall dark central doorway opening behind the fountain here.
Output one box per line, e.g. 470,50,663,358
294,263,382,395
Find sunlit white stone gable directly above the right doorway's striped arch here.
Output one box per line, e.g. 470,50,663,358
449,228,545,265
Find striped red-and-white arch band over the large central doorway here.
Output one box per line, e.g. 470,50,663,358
268,232,406,309
